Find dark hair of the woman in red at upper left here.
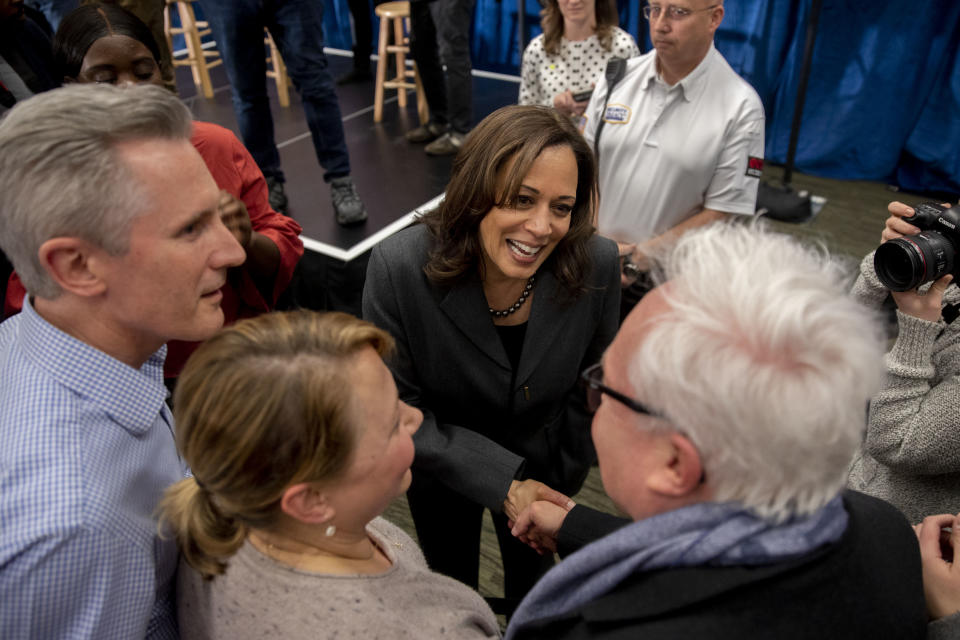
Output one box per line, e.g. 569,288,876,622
53,3,160,79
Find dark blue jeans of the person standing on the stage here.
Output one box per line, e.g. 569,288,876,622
200,0,350,182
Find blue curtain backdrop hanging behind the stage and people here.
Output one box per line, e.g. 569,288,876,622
300,0,960,192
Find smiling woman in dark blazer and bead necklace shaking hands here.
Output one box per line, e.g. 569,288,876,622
363,106,620,599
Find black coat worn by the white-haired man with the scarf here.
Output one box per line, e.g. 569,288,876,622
516,491,927,640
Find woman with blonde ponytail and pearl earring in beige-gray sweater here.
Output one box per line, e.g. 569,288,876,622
161,311,499,640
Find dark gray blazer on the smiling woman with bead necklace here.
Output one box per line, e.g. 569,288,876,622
363,224,620,512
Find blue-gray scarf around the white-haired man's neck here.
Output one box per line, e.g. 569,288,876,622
504,496,847,640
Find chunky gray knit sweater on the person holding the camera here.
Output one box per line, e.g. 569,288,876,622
849,253,960,522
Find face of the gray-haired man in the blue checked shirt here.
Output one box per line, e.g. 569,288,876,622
91,140,245,362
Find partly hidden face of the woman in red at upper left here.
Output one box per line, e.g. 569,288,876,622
75,35,163,86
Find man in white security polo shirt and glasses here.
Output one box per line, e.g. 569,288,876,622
583,0,764,315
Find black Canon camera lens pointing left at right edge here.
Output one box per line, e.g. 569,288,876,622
873,231,955,291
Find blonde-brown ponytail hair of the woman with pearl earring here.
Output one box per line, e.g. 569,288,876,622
158,311,393,579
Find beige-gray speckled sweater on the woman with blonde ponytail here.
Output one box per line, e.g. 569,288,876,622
177,518,500,640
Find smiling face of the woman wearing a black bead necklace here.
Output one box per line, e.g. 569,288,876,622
479,146,577,281
